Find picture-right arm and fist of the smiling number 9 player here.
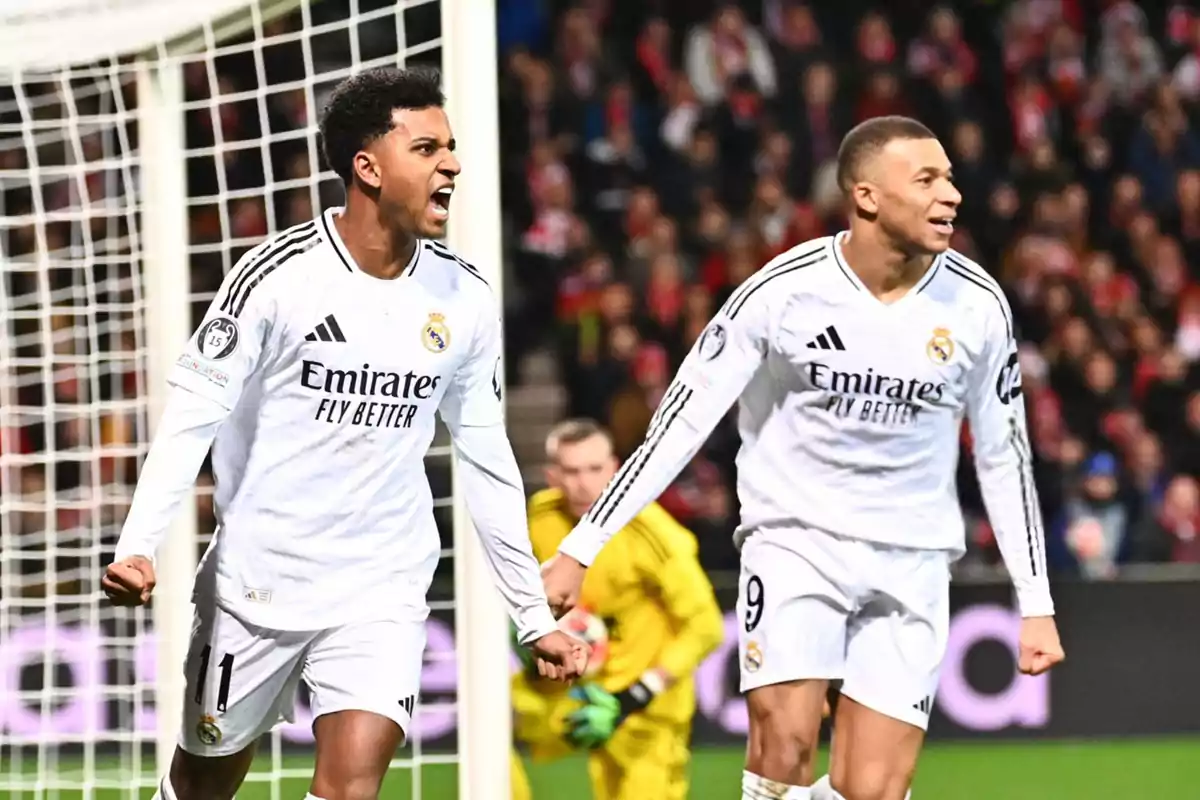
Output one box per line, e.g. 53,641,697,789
967,295,1062,673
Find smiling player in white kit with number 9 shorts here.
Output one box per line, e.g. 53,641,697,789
544,116,1063,800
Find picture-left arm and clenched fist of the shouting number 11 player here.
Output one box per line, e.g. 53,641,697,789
102,247,278,606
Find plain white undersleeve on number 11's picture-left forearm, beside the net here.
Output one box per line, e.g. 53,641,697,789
116,387,229,560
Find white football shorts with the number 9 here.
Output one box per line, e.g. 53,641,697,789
738,527,952,729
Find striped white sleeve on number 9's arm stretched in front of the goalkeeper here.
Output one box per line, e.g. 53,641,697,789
552,273,768,568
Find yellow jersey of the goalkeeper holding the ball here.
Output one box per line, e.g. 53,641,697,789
529,489,724,722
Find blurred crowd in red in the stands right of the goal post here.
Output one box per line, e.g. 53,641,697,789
500,0,1200,578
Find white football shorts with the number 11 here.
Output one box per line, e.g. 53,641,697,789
179,603,425,756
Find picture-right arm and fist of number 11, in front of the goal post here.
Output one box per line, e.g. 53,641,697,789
440,303,584,678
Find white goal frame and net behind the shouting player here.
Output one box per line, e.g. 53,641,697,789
0,0,511,800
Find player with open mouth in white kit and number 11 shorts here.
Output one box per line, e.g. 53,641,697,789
103,68,586,800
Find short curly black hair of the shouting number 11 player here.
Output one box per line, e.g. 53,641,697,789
320,66,446,184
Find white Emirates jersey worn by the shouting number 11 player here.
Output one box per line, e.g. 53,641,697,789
118,209,554,633
